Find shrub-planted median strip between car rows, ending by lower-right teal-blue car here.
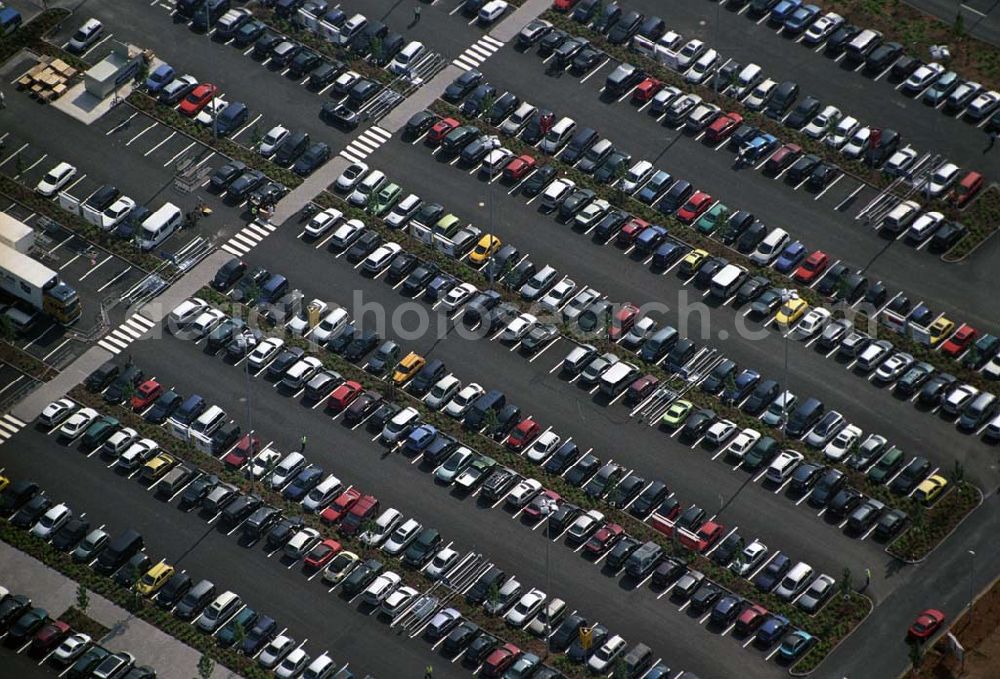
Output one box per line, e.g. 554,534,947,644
189,288,871,664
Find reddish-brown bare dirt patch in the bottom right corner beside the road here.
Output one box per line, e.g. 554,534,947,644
913,580,1000,679
